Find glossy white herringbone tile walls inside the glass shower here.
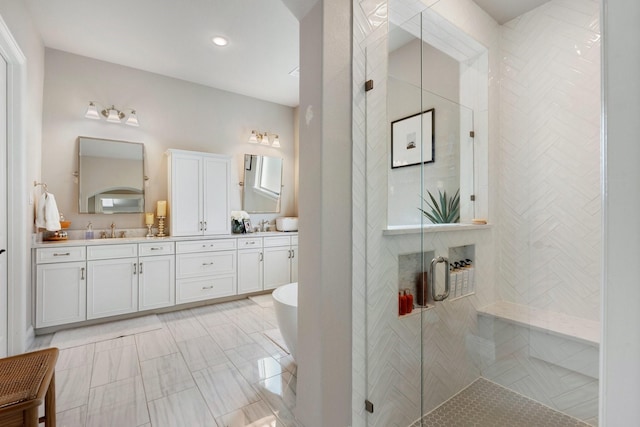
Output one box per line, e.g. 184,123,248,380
352,0,600,427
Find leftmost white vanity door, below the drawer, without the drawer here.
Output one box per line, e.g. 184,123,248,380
36,261,87,328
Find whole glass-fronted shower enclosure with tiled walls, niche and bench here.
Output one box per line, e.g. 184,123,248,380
353,0,601,427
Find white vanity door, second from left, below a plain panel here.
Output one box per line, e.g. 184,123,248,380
87,258,138,319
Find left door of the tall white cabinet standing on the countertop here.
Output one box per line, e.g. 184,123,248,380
169,153,204,236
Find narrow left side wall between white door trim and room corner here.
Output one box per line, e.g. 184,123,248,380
0,0,44,353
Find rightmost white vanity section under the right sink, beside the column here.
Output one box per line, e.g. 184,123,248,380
263,236,298,289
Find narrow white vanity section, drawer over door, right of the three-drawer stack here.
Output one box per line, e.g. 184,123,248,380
238,237,264,294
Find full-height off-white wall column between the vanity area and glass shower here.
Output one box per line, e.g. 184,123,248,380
295,0,352,427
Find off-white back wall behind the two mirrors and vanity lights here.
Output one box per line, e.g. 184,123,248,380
42,49,297,237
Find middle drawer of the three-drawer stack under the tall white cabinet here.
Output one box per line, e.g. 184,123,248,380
176,251,236,279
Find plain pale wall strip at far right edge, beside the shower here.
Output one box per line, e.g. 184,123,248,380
600,0,640,427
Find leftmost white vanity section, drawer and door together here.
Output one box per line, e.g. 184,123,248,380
35,246,87,328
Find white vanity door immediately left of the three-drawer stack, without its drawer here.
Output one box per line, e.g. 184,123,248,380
138,255,176,310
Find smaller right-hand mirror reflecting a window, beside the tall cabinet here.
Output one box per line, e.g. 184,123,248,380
242,154,282,213
